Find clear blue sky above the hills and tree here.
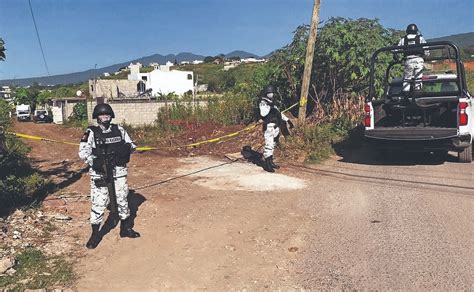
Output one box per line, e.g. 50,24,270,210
0,0,474,79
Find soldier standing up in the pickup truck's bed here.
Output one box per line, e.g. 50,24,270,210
398,23,429,96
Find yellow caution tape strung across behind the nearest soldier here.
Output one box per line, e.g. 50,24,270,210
4,103,299,151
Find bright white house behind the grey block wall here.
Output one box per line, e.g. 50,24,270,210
128,62,194,96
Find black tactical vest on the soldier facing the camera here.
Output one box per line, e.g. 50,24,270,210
89,124,130,166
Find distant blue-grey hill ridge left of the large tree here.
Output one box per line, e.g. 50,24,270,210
0,51,258,86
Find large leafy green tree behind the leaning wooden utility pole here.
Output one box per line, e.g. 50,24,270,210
270,17,398,100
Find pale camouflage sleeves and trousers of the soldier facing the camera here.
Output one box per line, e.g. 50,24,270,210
79,124,136,224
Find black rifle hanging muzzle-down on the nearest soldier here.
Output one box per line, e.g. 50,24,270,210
97,137,118,218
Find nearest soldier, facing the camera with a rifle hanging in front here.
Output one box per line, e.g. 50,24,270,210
79,103,140,249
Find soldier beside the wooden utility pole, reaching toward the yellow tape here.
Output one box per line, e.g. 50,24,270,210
258,85,293,172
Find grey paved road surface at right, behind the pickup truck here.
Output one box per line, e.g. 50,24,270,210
296,149,474,291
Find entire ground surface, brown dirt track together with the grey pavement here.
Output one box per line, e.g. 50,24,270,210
11,123,474,291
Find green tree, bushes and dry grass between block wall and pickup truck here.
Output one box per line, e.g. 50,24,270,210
146,18,401,162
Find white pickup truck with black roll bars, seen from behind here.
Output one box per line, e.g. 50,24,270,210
364,42,474,163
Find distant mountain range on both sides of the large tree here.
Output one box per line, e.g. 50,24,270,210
0,32,474,86
